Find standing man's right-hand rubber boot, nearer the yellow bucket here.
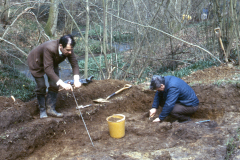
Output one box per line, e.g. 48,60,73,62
46,91,63,117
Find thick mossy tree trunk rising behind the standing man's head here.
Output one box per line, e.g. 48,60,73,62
45,0,59,37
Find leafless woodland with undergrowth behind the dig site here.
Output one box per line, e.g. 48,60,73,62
0,0,240,100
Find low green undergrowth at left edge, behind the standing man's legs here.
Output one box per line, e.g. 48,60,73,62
0,65,35,101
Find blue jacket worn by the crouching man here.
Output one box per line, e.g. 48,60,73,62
152,76,199,121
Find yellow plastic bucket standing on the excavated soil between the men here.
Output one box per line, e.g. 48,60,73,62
106,114,125,138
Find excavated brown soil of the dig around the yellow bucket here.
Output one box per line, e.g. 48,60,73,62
0,65,240,160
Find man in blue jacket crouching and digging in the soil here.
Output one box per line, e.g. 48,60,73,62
150,75,199,122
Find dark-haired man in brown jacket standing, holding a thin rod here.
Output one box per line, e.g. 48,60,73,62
27,34,81,118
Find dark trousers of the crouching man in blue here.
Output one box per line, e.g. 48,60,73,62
170,103,198,121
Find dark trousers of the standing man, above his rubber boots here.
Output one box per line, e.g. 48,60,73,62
33,66,59,95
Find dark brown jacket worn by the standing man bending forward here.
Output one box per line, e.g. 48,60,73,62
27,40,79,82
